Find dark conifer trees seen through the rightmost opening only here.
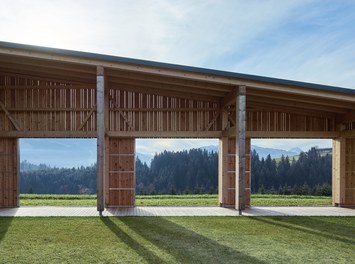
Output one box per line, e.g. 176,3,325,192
251,148,332,196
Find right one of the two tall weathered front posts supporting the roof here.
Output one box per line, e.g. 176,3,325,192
235,86,246,214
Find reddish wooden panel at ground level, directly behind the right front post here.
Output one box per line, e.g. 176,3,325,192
218,138,251,207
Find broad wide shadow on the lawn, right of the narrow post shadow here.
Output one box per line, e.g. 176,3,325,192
115,217,265,264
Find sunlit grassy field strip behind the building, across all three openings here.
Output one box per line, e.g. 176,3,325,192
20,194,332,206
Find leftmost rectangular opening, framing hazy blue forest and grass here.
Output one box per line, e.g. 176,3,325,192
19,138,97,206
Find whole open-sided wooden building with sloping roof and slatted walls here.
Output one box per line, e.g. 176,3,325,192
0,42,355,212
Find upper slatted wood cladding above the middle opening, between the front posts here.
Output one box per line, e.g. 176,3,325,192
109,89,220,132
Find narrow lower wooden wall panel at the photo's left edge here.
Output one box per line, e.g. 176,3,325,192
0,138,19,207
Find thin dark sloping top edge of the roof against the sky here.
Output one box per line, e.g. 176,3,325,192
0,41,355,94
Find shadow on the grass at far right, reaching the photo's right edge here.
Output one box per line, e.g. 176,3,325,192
253,216,355,245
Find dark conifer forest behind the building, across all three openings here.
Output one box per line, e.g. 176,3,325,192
20,148,332,195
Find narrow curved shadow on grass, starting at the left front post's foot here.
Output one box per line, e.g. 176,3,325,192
100,217,164,263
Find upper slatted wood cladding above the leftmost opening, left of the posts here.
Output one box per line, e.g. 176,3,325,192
0,73,96,131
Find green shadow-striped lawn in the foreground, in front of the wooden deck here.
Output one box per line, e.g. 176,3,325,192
0,217,355,263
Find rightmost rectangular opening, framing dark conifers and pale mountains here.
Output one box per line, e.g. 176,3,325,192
251,139,332,206
